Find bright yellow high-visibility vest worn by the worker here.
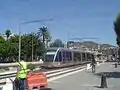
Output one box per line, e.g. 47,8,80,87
17,61,27,79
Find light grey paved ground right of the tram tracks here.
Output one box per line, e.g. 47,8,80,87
48,63,120,90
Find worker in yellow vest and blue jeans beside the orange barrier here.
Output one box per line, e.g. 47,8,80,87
17,60,27,90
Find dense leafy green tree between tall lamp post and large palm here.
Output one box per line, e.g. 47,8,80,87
21,33,43,60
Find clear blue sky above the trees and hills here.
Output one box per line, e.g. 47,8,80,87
0,0,120,44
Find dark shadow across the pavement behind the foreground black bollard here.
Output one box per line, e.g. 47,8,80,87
94,72,120,78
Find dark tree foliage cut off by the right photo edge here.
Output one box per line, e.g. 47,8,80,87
114,13,120,46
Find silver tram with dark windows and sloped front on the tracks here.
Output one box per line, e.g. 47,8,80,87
43,48,94,68
